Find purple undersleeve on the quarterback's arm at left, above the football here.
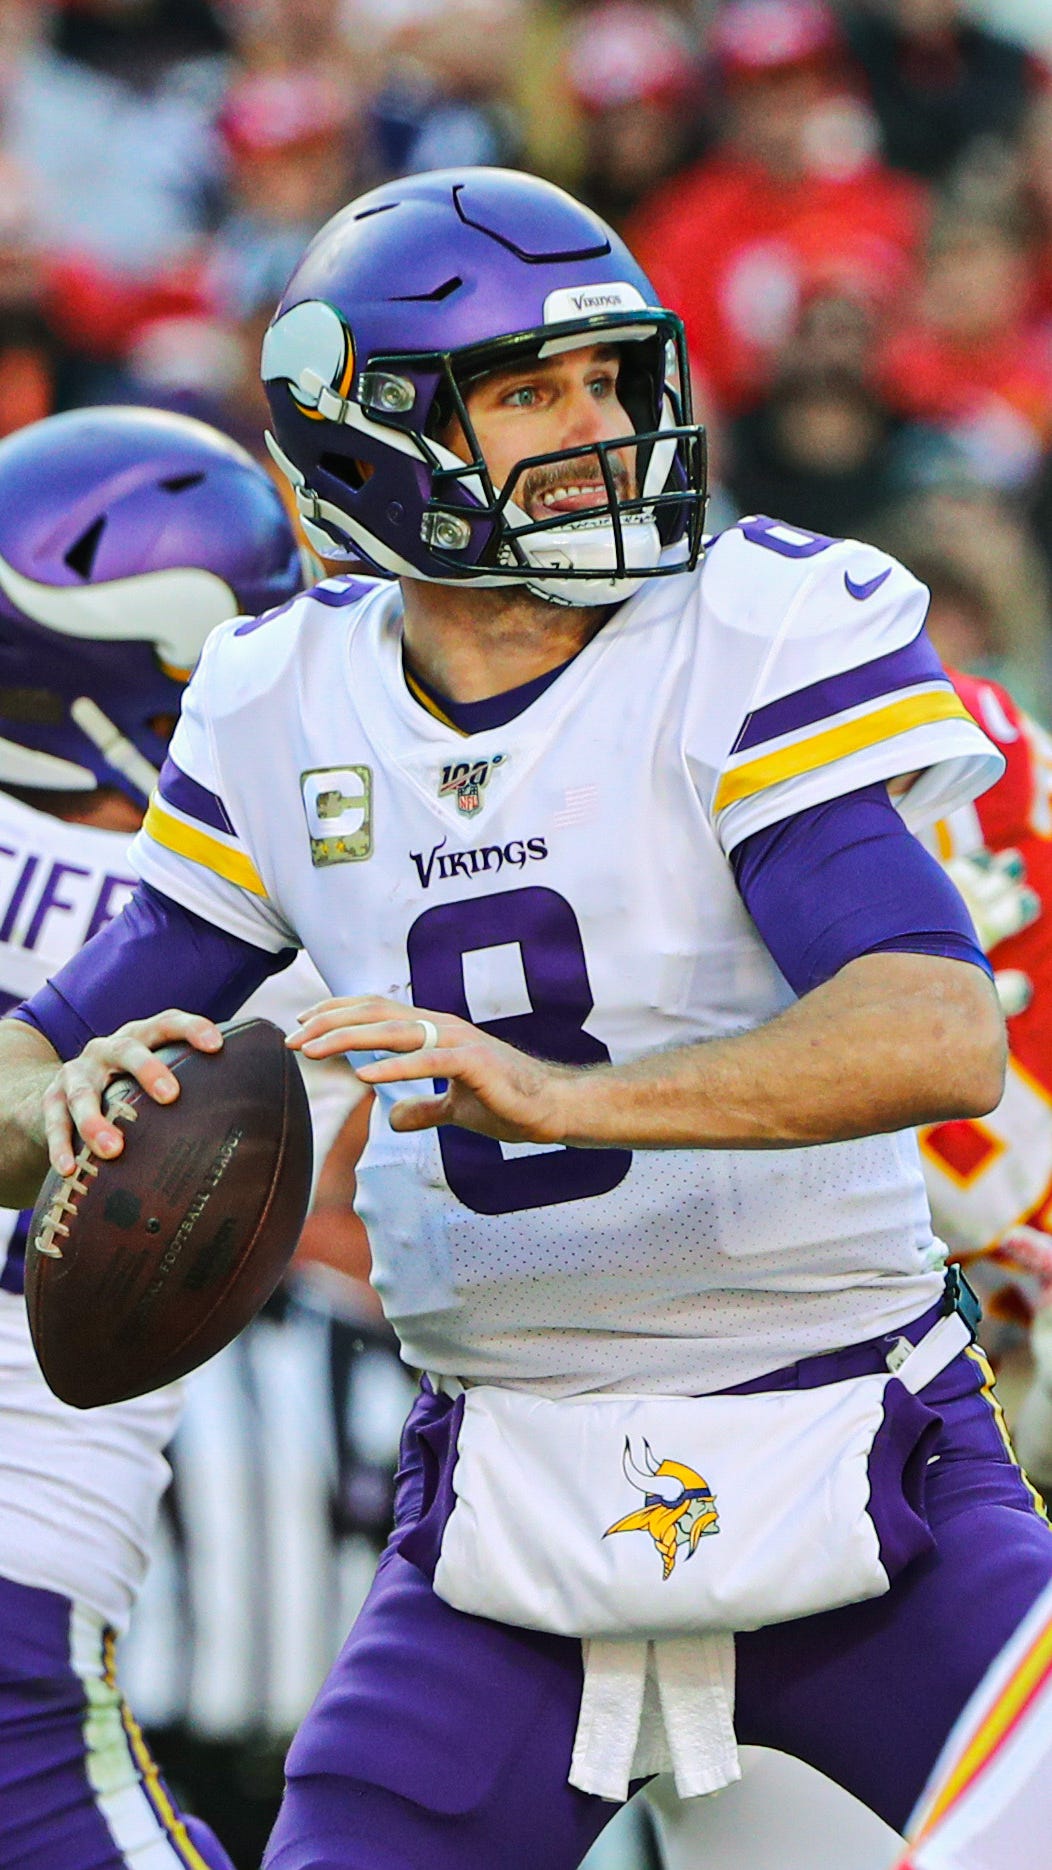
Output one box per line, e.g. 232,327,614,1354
11,883,297,1058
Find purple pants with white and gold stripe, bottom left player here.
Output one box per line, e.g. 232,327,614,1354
0,1578,234,1870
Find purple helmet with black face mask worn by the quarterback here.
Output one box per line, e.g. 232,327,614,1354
262,168,706,604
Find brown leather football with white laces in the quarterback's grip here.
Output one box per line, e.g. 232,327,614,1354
26,1019,312,1408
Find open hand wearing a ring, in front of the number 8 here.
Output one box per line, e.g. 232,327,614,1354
286,995,579,1143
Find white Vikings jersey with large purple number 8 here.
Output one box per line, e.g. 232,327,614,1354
133,522,1000,1395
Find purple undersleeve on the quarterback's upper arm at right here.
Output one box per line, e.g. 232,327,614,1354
731,784,992,993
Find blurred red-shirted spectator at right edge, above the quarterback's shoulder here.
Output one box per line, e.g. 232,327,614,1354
882,202,1052,486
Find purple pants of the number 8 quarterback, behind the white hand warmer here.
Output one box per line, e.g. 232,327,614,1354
265,1318,1052,1870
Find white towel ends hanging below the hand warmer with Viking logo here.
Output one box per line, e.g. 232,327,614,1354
570,1631,742,1803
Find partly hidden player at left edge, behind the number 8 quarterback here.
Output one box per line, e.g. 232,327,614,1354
0,410,317,1870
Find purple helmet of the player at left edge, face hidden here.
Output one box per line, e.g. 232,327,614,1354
0,408,308,804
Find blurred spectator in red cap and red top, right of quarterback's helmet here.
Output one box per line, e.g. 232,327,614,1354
630,0,927,413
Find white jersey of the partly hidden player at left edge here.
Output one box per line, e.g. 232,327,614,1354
0,791,355,1631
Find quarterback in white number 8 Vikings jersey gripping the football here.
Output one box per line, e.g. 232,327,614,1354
0,170,1052,1870
